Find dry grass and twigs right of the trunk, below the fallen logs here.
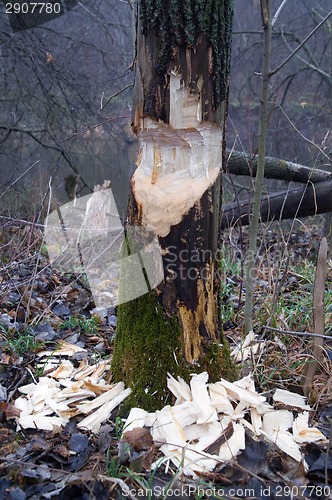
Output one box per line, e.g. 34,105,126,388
222,218,332,407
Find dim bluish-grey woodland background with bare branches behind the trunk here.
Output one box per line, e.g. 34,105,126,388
0,0,332,220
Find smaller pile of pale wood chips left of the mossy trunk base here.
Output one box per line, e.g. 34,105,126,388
15,342,131,434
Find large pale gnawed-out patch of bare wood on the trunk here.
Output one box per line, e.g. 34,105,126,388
132,118,222,237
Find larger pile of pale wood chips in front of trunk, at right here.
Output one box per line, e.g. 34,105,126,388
125,372,326,477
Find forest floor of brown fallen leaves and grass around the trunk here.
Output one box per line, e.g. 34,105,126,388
0,218,332,500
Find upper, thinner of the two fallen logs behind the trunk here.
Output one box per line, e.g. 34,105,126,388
226,149,332,184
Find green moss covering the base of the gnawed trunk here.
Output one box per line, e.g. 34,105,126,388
112,292,185,411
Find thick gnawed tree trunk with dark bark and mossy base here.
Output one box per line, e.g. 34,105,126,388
112,0,234,409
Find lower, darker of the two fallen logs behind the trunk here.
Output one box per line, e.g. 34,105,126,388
221,180,332,229
